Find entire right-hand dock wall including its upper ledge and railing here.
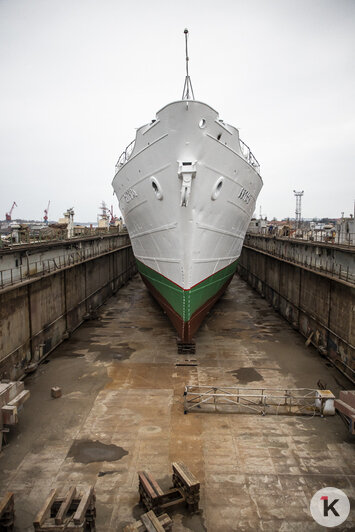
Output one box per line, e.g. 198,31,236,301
238,235,355,381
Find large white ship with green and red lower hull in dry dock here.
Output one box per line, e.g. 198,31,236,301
112,30,263,346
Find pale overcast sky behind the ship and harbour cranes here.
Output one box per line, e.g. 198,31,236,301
0,0,355,221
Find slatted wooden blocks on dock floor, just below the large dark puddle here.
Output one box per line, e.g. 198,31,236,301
33,486,96,532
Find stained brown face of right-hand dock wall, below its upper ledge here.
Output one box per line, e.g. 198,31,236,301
237,246,355,378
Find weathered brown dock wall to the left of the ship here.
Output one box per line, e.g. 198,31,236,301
0,235,136,380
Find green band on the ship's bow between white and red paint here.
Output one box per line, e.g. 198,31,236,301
136,259,237,321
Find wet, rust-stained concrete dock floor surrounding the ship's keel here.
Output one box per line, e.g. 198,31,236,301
0,277,355,532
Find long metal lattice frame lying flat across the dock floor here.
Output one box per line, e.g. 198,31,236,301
184,385,335,416
